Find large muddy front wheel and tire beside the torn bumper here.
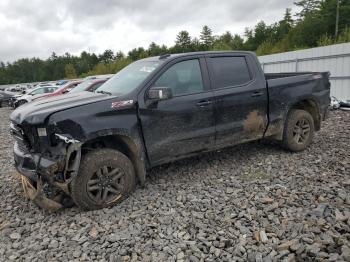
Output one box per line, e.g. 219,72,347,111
70,149,135,210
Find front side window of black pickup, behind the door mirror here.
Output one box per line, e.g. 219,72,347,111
154,59,204,96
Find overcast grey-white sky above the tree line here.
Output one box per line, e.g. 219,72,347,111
0,0,293,62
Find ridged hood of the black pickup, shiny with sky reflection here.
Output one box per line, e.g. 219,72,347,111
10,92,115,125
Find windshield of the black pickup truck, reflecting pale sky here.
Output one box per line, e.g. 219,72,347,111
96,61,161,96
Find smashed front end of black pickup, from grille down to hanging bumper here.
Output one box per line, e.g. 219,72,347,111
11,123,82,211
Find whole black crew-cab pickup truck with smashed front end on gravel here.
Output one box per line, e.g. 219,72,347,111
11,52,330,210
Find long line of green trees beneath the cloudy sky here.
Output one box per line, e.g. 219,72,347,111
0,0,350,84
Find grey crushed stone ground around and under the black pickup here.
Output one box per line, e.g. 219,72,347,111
0,108,350,261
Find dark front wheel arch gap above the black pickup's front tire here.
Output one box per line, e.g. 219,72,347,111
81,135,146,185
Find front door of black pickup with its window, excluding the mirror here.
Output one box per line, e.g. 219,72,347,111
139,56,215,166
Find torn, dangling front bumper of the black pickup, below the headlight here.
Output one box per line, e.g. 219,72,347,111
14,135,81,211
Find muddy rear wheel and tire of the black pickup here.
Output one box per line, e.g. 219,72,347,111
283,109,315,152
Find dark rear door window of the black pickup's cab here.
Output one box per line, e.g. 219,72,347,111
211,56,252,89
